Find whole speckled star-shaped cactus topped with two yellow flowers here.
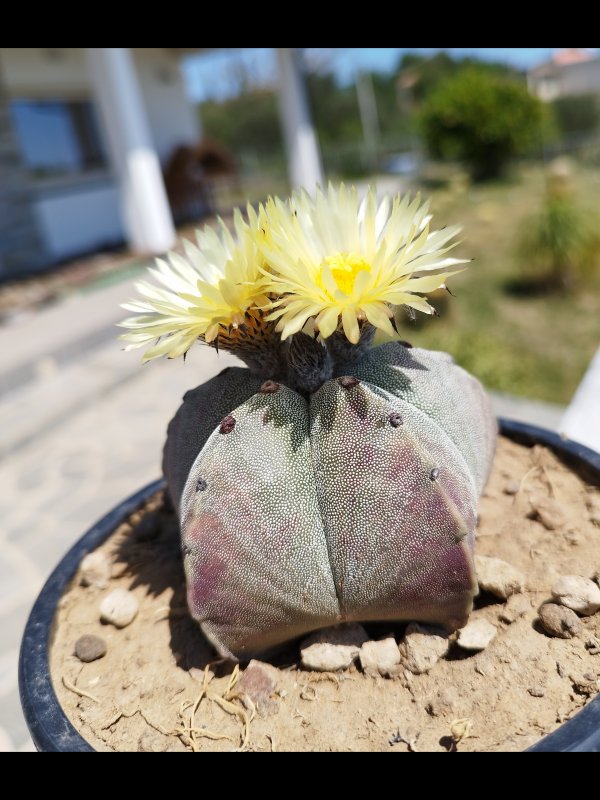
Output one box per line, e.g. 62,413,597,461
122,186,496,658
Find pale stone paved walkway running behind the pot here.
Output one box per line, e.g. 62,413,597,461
0,282,563,751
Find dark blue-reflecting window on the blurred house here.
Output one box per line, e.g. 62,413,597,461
10,98,106,178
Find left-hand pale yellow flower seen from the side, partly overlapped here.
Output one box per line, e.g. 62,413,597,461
120,207,268,361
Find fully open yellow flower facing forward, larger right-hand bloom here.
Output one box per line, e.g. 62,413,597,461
259,184,466,343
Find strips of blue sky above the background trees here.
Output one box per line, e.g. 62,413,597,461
185,47,584,100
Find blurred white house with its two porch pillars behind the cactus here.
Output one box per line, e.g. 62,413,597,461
0,48,321,280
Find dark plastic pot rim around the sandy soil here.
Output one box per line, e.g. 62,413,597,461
19,419,600,753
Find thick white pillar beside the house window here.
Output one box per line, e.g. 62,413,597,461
88,47,176,254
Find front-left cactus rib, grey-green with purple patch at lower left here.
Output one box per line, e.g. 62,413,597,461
176,386,339,657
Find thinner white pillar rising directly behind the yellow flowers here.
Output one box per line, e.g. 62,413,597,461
277,47,323,192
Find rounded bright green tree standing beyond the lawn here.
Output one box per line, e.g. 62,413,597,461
420,66,545,180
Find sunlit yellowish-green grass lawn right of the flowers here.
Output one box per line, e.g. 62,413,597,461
390,162,600,403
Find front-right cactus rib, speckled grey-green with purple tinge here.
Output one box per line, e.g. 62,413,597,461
311,381,477,628
